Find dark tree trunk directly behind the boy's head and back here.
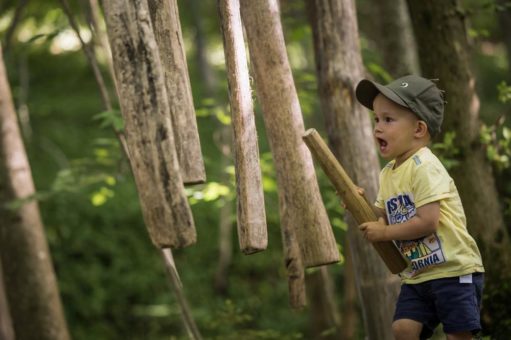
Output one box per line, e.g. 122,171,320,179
409,0,511,331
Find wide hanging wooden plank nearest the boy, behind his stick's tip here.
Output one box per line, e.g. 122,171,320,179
240,0,339,267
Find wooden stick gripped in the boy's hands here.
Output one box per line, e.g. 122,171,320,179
303,129,407,274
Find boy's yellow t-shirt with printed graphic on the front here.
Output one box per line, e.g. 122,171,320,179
375,147,484,284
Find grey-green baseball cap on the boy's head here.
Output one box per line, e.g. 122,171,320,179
355,75,444,136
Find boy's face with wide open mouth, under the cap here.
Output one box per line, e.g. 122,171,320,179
373,94,427,165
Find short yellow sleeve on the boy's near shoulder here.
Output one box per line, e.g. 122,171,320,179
412,162,452,208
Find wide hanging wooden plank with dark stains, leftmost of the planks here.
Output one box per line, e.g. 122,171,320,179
104,0,196,248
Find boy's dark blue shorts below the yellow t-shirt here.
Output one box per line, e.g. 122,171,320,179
394,273,484,339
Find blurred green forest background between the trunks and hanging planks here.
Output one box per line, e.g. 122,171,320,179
0,0,511,339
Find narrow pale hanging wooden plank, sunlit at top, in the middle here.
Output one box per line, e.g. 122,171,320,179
218,0,268,254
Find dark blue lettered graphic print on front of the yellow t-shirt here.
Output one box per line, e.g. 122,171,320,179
385,193,445,276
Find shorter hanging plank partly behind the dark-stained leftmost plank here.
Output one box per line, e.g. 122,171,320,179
148,0,206,184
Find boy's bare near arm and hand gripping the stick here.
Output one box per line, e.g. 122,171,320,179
359,201,440,242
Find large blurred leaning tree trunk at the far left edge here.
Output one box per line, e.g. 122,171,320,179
0,48,69,340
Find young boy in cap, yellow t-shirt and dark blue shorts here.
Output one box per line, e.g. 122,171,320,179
356,75,484,340
